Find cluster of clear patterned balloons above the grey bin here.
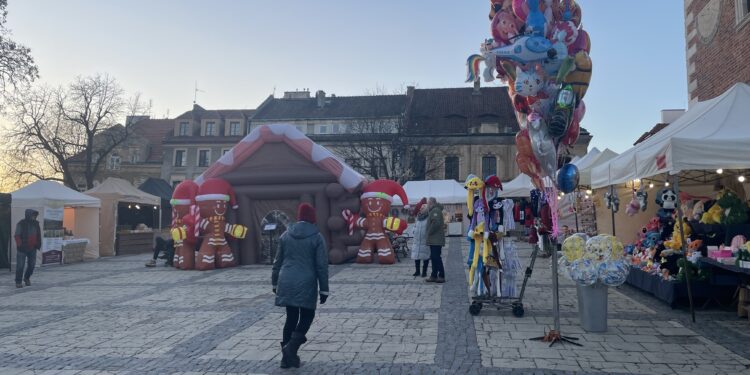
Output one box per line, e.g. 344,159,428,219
559,233,630,286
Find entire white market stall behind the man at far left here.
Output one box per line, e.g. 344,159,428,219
11,181,101,265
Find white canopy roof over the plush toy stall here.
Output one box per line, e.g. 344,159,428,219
591,83,750,188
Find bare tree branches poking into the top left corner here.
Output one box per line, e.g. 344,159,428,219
0,0,39,101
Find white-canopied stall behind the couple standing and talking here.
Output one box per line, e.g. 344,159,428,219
393,180,469,236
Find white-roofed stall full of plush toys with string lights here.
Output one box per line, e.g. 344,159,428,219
591,83,750,318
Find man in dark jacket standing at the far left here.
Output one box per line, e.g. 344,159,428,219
15,209,42,288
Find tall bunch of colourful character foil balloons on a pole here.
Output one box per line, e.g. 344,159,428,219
466,0,592,192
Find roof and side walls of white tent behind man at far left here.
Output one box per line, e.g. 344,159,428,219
11,180,101,259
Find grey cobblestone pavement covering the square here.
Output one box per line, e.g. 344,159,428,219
0,238,750,375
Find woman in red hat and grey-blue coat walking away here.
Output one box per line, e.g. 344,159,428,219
271,203,328,368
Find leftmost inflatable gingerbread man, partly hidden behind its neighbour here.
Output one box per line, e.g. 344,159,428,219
170,180,198,270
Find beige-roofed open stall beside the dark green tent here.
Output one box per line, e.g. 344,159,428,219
85,177,161,256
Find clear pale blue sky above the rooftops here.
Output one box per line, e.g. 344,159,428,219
8,0,687,152
